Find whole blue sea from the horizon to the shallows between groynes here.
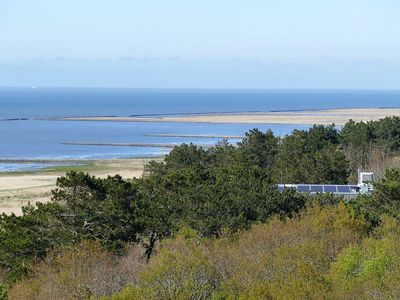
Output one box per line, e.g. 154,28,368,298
0,87,400,172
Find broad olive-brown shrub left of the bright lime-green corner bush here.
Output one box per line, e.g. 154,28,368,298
211,203,366,299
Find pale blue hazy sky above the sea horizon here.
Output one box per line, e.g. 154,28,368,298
0,0,400,89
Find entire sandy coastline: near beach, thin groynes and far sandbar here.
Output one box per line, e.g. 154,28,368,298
0,108,400,214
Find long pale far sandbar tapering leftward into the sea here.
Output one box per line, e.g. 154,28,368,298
59,108,400,125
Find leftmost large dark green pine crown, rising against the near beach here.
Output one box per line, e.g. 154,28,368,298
52,171,142,251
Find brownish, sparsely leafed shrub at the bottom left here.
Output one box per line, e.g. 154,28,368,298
8,241,145,300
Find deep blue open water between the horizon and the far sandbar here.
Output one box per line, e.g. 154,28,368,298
0,88,400,119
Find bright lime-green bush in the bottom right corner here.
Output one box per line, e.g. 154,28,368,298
330,224,400,299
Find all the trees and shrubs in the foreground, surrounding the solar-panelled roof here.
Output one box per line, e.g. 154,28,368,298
0,118,400,299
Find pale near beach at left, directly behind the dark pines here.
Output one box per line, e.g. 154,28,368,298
0,158,159,215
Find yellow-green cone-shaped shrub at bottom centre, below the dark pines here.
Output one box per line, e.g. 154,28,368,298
129,229,219,299
